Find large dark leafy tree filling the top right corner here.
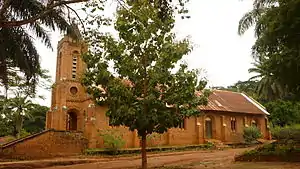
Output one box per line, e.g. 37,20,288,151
239,0,300,100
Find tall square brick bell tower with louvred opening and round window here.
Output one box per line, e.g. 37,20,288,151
46,36,90,131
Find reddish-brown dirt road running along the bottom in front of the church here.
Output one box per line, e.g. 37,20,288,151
42,149,300,169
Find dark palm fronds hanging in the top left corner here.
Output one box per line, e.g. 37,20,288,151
0,0,79,89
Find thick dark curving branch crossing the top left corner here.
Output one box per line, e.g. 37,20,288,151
0,0,88,28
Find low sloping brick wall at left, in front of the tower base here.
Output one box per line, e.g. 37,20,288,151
0,130,87,159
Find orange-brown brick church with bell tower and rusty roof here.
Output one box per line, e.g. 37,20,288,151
46,36,269,148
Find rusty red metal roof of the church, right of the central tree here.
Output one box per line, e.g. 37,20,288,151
199,90,269,115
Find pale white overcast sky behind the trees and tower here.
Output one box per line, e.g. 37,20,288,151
35,0,255,106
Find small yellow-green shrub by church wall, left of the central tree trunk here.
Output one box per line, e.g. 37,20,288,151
99,129,125,151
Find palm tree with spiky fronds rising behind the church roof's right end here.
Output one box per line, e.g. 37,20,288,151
249,60,287,100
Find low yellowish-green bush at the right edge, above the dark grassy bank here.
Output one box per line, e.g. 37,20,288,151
271,125,300,143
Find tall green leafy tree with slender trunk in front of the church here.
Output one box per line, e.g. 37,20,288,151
82,0,209,169
